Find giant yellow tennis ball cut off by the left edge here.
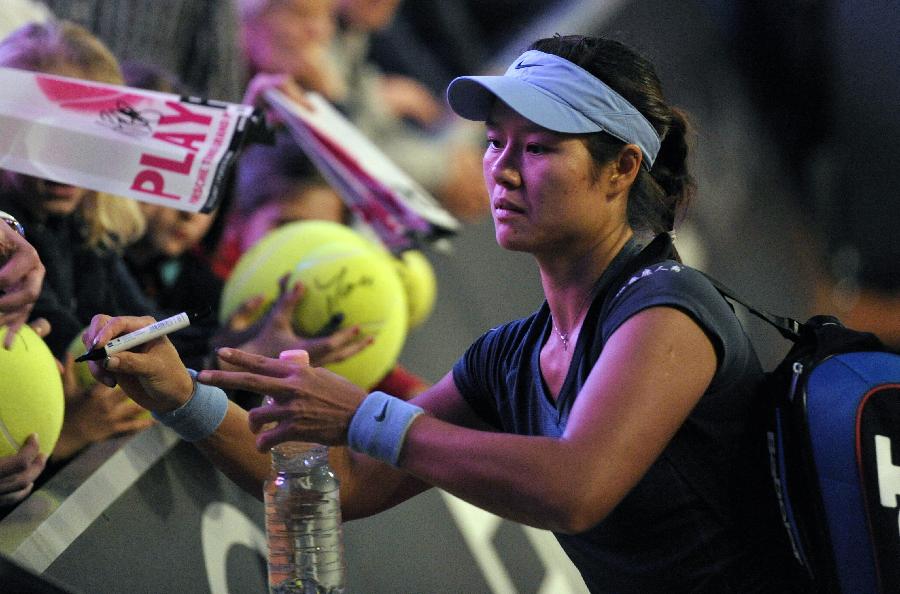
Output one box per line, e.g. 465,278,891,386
0,326,65,456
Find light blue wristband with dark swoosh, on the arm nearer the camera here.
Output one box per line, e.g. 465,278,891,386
347,392,424,466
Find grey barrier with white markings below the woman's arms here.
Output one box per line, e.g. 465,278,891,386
0,426,584,594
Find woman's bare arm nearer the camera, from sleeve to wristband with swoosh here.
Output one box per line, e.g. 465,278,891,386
400,307,716,533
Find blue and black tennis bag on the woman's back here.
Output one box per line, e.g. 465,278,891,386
763,316,900,594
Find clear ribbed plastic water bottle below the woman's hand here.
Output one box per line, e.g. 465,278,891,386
265,443,347,594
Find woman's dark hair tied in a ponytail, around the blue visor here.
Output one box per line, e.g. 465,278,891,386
529,35,695,234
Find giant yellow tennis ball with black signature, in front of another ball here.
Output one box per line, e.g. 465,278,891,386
291,242,407,389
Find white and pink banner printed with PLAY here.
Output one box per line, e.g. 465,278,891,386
0,68,262,212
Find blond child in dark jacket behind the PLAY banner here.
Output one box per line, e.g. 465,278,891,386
0,21,155,462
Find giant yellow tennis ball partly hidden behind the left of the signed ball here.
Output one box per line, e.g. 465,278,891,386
219,221,373,324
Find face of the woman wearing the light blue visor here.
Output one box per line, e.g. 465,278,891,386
483,101,612,254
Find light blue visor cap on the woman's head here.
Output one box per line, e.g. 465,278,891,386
447,50,661,169
